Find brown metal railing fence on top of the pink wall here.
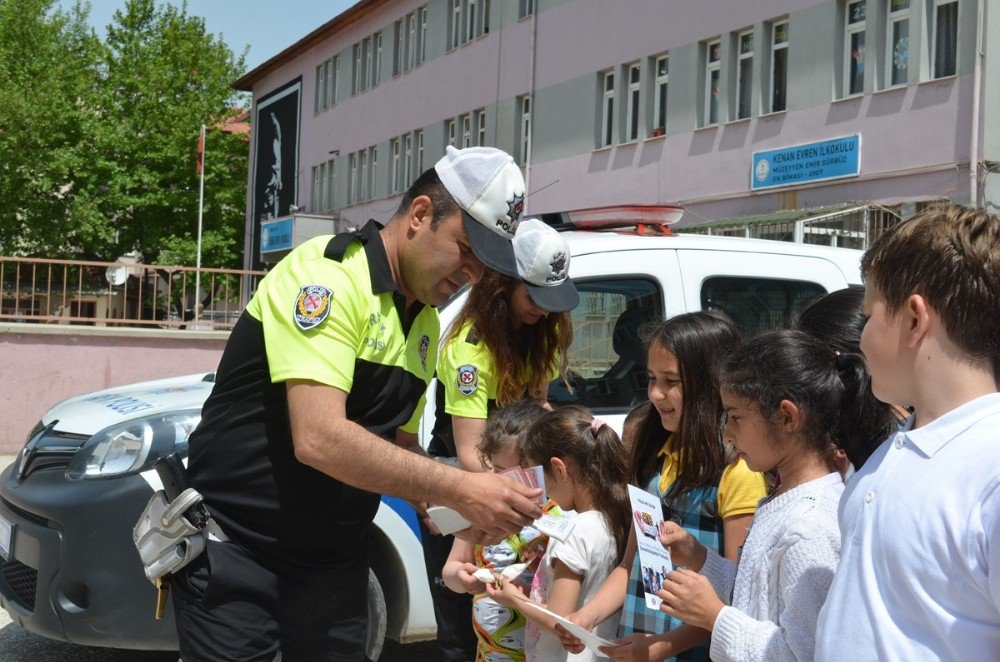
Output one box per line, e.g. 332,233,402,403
0,257,264,330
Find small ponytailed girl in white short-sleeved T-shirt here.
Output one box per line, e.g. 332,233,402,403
486,405,632,662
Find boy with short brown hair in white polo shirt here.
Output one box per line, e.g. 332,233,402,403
816,206,1000,662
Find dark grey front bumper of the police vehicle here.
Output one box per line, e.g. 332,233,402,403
0,462,177,650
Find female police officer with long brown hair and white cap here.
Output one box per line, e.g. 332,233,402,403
421,219,579,662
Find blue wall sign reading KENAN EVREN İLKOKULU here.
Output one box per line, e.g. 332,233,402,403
750,133,861,191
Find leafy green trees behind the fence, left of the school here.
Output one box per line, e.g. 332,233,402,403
0,0,248,266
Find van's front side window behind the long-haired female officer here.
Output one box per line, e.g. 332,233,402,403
549,278,663,414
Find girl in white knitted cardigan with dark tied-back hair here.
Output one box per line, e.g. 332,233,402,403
659,331,887,660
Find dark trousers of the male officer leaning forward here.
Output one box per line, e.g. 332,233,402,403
171,542,368,662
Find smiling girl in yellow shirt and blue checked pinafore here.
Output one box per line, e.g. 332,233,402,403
563,312,767,660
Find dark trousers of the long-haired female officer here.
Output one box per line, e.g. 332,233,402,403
420,522,476,662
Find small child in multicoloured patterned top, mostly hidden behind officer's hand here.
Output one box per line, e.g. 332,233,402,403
442,400,558,662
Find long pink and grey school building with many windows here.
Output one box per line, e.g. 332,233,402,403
235,0,1000,268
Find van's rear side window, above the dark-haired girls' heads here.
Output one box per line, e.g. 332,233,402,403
701,276,826,337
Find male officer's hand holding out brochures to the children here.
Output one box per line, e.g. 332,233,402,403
453,473,542,535
